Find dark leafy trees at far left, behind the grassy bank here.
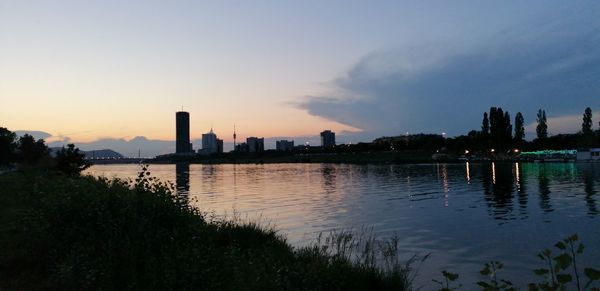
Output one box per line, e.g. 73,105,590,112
0,127,90,175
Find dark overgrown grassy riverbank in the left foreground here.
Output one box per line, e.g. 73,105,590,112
0,169,410,290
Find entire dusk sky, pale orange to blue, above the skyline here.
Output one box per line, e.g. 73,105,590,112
0,0,600,155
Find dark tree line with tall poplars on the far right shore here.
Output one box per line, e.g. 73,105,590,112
368,107,600,154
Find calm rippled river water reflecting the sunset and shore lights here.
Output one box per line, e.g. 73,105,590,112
89,163,600,290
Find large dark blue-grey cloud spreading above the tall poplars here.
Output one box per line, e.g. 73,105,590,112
298,3,600,139
